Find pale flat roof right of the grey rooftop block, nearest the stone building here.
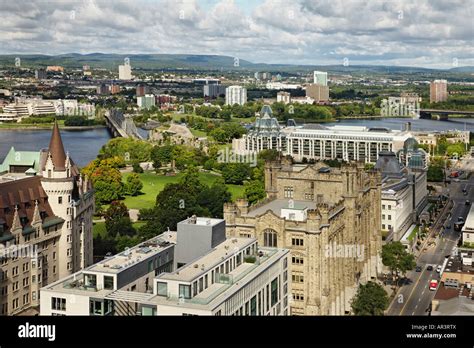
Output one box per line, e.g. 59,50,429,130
160,238,255,282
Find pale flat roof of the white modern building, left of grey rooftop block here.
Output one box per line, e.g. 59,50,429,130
88,232,176,273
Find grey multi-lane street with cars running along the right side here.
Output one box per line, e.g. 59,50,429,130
388,159,474,315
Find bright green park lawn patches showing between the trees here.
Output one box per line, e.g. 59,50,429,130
123,172,244,209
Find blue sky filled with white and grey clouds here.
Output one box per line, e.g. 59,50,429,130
0,0,474,68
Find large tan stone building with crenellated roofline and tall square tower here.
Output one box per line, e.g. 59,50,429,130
224,159,382,315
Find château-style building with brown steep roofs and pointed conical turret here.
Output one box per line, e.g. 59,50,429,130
0,123,94,315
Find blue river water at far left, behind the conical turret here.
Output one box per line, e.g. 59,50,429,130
0,128,111,167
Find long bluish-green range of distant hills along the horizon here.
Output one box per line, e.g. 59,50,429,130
0,53,474,76
